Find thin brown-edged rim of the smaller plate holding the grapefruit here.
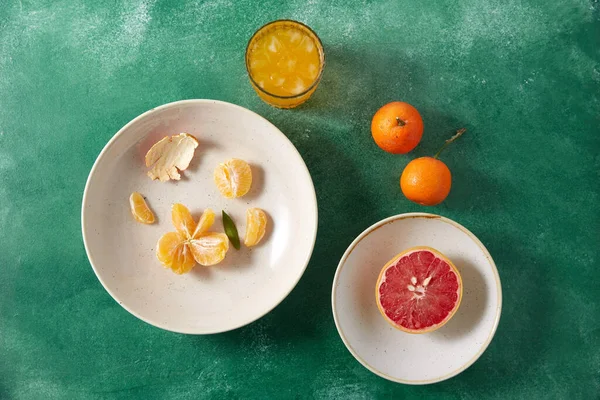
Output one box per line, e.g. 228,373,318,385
331,212,502,385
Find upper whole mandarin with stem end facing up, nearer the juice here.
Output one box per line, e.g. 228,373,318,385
371,101,423,154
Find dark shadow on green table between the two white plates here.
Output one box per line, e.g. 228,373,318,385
268,134,376,341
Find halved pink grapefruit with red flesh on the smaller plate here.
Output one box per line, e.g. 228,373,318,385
375,247,462,333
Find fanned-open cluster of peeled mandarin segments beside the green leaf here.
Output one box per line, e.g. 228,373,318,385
156,204,229,274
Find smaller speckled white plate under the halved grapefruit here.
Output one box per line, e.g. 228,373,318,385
331,213,502,385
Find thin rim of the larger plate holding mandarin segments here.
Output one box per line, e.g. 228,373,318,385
80,99,319,335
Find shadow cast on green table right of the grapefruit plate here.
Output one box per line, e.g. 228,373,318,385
426,231,555,394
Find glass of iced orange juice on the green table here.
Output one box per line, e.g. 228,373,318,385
246,19,325,108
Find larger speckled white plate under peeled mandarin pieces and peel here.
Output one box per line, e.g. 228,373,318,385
81,100,317,334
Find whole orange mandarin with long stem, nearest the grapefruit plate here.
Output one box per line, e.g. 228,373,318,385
400,128,466,206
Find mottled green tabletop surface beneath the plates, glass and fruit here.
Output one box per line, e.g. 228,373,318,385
0,0,600,399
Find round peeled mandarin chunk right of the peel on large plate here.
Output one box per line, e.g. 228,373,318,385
214,158,252,199
